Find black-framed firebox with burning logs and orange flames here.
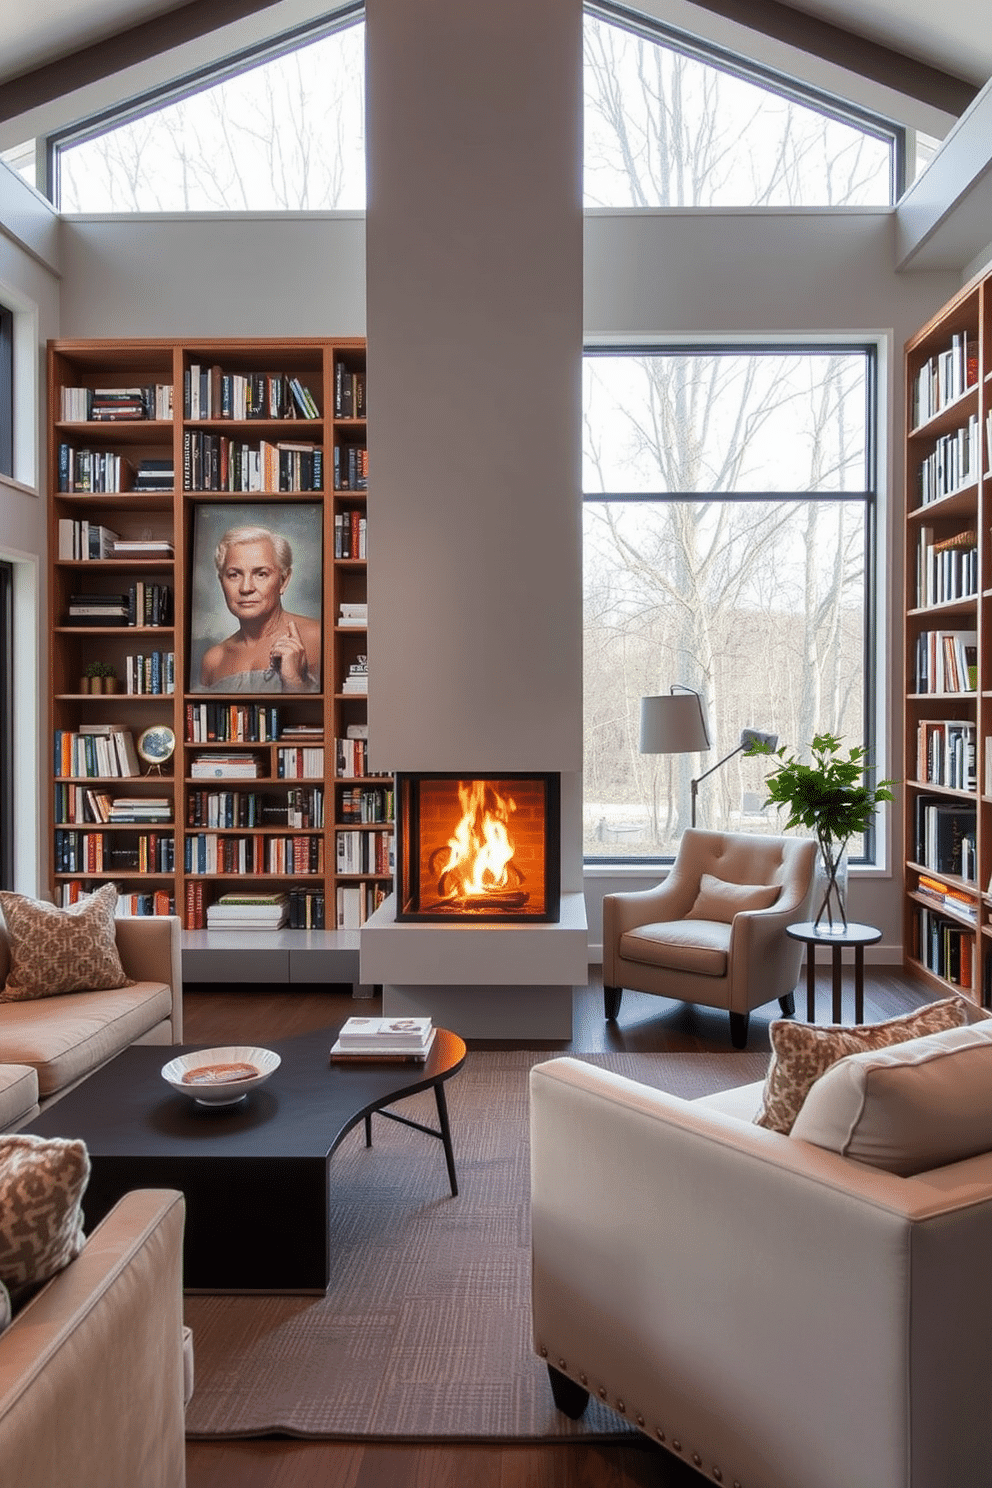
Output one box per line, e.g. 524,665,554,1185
396,772,561,926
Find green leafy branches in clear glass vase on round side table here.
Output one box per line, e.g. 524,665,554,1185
745,734,897,933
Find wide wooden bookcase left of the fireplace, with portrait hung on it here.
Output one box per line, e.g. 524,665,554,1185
48,339,393,930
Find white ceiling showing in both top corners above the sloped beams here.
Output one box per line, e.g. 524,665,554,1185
0,0,992,86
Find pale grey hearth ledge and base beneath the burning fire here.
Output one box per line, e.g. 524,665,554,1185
360,891,589,1039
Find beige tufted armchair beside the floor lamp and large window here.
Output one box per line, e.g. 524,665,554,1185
602,827,817,1049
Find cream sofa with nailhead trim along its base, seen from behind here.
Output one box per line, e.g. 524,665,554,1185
531,1031,992,1488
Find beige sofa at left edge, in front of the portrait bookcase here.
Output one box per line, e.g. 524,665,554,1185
0,915,183,1131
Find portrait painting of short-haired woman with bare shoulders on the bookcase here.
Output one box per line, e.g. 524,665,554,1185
189,501,323,693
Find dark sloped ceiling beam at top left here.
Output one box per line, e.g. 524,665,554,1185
0,0,285,121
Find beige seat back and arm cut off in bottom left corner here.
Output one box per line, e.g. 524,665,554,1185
0,1189,192,1488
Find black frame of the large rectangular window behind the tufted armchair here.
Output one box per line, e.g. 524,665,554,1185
582,339,880,869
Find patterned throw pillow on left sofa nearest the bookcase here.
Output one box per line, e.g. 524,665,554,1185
0,884,132,1003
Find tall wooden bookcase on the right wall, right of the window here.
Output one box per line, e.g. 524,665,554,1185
903,277,992,1004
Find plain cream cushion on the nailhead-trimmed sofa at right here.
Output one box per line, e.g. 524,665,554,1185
791,1021,992,1177
